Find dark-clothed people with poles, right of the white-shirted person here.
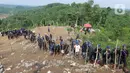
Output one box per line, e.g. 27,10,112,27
82,42,129,67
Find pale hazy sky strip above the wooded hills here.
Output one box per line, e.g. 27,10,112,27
0,0,130,9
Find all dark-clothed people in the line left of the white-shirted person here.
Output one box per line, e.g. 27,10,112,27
1,27,69,54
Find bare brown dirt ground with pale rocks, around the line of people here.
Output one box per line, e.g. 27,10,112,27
0,27,122,73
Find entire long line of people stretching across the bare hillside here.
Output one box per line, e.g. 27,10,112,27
1,28,129,67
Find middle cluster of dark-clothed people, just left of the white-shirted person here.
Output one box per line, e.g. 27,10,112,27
37,34,69,55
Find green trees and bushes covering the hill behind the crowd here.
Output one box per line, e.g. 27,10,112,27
0,0,130,66
